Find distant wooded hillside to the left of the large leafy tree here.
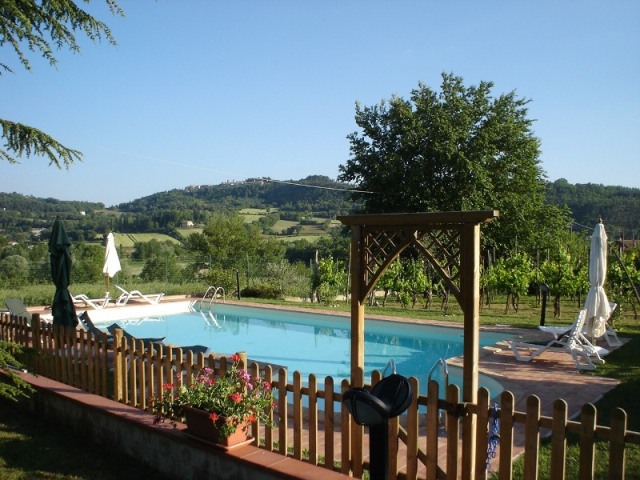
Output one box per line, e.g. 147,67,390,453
0,176,357,241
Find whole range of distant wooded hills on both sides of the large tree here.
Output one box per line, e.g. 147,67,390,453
0,176,640,241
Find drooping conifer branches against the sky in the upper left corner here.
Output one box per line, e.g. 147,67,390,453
0,0,124,168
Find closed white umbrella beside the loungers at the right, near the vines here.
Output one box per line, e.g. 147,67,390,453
584,221,611,338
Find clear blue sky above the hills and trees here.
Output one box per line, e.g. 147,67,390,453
0,0,640,206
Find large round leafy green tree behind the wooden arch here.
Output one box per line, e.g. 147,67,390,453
339,74,568,255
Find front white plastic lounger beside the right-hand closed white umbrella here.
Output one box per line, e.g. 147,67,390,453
509,310,608,370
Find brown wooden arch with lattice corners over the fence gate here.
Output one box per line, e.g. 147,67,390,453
337,210,498,475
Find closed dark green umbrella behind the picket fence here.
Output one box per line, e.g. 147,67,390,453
49,220,78,327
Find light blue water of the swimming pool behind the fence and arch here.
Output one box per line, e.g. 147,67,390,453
101,304,508,396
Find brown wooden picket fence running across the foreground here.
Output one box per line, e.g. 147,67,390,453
0,314,640,480
